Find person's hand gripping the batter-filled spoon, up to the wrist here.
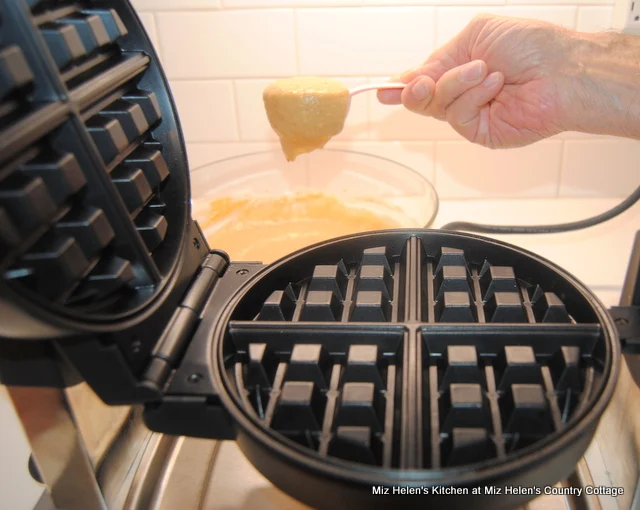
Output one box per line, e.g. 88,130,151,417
378,16,584,148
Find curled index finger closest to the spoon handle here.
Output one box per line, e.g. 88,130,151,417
401,60,488,120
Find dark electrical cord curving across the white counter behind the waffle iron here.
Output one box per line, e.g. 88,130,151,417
440,186,640,234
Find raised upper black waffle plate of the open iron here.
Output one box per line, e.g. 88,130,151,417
0,0,189,321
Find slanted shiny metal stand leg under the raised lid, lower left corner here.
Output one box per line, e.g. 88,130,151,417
7,387,107,510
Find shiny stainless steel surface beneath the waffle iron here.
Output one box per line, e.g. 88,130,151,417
9,364,640,510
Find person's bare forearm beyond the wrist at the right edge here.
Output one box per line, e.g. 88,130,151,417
567,33,640,139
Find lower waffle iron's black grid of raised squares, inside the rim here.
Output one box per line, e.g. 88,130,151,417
229,241,601,470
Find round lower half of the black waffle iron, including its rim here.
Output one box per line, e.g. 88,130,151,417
214,231,618,508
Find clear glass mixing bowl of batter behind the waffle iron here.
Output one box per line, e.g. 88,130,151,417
191,149,438,263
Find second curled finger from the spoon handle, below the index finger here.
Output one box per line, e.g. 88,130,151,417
446,72,504,142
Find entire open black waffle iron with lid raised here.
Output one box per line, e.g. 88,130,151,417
0,0,640,509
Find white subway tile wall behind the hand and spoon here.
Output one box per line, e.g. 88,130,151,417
133,0,640,199
